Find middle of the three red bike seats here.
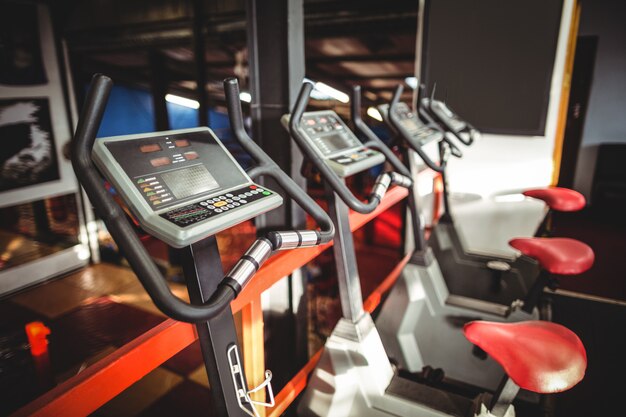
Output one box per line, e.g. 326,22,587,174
509,237,595,275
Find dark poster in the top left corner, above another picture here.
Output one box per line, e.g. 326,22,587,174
0,2,48,86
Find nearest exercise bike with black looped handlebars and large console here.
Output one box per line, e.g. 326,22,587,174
72,75,334,417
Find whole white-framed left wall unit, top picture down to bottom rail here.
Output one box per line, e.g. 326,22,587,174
0,2,94,294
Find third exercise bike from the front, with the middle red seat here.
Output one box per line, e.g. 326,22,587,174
368,84,593,390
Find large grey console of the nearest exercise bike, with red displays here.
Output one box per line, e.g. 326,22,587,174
93,128,282,248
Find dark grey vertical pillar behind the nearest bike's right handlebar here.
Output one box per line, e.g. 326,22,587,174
246,0,308,376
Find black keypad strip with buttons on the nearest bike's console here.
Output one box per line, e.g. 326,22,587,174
161,185,272,227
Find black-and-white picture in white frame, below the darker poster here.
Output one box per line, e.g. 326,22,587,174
0,98,60,192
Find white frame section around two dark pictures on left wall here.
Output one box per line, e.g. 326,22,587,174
0,2,78,207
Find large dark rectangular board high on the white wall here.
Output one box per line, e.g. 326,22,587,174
422,0,562,135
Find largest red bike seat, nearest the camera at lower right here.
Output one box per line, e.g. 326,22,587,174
463,320,587,394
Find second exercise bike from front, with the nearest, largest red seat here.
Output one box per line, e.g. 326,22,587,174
282,82,586,417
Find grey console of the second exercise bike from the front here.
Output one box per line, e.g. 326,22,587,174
281,110,385,177
